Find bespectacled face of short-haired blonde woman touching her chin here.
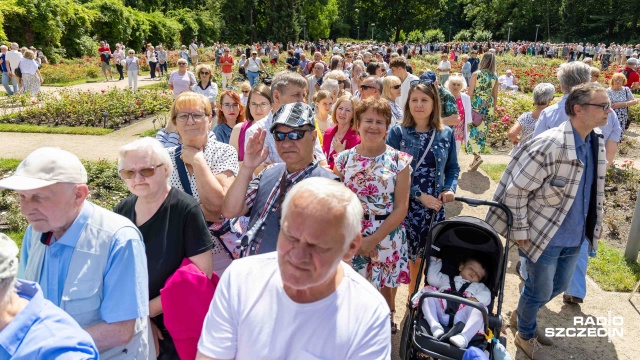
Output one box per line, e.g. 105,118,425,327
176,104,213,149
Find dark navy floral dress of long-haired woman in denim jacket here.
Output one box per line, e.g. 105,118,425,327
405,131,444,261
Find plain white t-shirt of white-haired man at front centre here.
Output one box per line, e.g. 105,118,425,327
198,252,391,360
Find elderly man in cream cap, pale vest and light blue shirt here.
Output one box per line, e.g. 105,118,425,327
0,147,149,359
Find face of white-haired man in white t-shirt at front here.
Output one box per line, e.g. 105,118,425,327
277,193,347,290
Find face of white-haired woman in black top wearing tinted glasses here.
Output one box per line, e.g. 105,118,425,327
121,149,169,197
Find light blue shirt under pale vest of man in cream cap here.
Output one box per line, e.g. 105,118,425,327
18,201,149,323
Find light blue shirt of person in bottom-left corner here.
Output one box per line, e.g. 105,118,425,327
0,280,98,360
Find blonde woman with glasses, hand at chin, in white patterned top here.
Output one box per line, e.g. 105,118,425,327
169,92,238,275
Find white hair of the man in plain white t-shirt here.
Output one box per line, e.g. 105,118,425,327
280,177,364,251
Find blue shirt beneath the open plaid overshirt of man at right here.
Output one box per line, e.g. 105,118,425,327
549,131,596,247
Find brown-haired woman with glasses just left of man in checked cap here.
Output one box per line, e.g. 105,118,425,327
229,84,271,161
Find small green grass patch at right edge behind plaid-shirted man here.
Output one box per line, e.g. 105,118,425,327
587,241,640,292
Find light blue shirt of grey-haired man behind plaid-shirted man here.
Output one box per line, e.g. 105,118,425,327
531,94,622,143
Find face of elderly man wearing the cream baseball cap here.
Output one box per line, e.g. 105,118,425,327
17,183,86,232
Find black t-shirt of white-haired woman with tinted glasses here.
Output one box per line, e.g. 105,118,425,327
114,187,213,299
